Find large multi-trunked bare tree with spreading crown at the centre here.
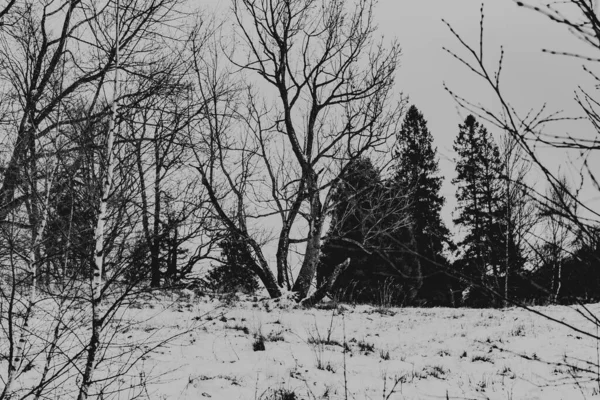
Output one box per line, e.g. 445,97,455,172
194,0,404,301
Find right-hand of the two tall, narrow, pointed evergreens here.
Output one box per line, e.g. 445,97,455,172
452,115,506,302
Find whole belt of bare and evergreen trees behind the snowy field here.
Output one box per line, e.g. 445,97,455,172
0,0,600,312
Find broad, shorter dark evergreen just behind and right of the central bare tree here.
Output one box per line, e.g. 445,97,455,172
317,158,421,305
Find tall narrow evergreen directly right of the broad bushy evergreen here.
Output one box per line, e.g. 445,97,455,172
393,105,450,303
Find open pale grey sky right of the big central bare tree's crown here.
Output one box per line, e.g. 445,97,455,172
376,0,593,230
